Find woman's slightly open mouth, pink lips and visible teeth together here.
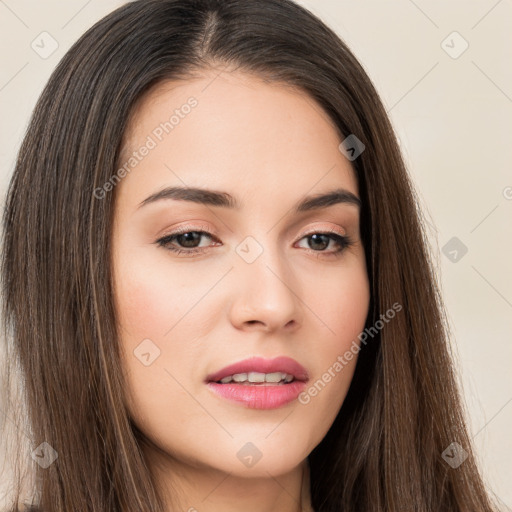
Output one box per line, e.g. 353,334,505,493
205,357,309,409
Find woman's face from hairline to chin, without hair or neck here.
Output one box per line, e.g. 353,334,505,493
111,72,369,482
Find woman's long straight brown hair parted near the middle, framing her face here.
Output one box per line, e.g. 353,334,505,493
1,0,494,512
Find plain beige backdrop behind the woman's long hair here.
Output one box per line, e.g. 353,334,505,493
0,0,512,509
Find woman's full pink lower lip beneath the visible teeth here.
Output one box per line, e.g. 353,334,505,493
208,380,306,409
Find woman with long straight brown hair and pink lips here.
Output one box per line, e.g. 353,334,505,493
2,0,494,512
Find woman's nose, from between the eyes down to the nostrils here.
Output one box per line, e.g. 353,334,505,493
230,243,303,332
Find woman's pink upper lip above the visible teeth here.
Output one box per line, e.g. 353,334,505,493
206,356,309,382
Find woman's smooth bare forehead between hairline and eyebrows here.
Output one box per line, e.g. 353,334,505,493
118,71,357,208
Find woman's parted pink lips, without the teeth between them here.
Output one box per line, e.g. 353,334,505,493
206,357,309,409
